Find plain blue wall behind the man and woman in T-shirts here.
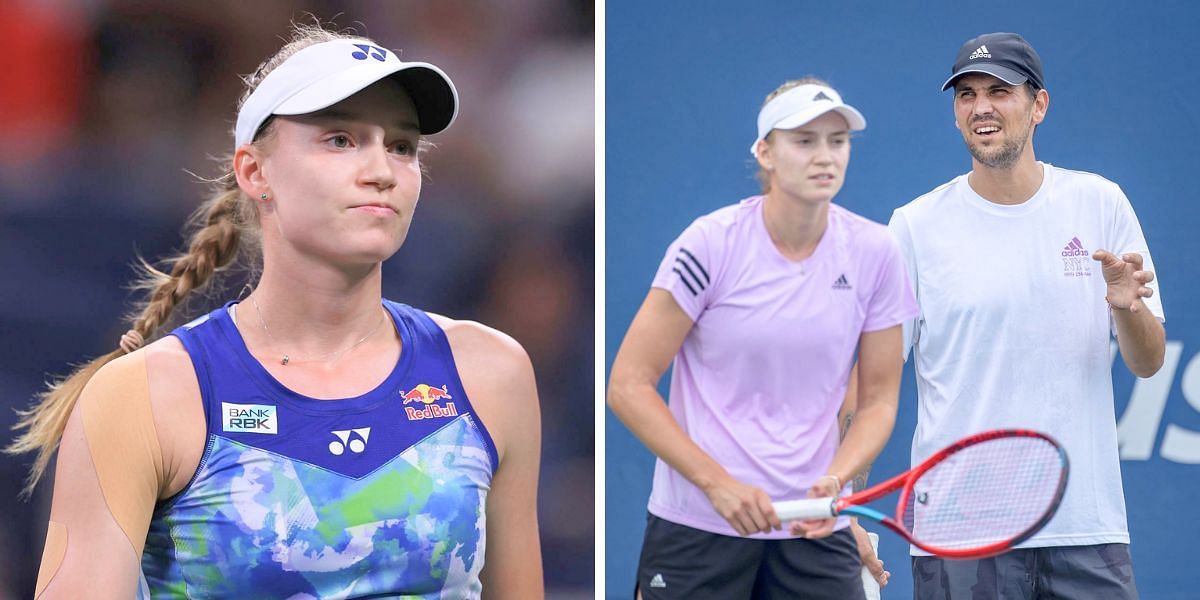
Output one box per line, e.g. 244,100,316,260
604,0,1200,599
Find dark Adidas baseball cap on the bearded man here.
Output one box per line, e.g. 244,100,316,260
942,32,1045,91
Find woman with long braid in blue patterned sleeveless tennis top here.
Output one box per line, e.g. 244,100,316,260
10,26,542,599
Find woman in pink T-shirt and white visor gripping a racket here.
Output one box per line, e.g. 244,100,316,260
608,79,917,600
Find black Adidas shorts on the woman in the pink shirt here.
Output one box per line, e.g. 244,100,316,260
634,515,865,600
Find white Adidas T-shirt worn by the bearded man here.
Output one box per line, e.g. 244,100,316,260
888,163,1164,554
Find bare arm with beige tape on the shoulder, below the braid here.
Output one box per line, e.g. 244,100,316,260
37,350,163,600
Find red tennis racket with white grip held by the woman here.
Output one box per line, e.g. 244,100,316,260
774,430,1070,558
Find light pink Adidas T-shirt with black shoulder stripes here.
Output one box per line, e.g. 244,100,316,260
648,196,917,539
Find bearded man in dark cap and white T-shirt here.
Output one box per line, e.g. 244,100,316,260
888,34,1165,599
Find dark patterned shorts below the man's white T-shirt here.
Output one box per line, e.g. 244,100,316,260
912,544,1138,600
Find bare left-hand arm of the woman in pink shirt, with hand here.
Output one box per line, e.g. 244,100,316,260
608,288,781,535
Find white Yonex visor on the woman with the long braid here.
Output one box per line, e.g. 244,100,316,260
233,40,458,151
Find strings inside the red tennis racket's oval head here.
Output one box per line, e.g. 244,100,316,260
900,437,1064,550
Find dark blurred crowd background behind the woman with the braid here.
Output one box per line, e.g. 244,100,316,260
0,0,595,598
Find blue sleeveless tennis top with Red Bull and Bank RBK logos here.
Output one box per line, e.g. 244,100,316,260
142,301,498,599
